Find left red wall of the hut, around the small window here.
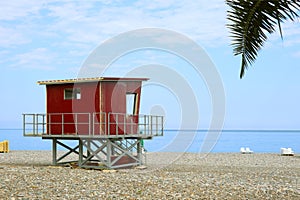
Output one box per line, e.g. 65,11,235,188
47,83,100,135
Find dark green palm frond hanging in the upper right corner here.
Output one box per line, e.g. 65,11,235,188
226,0,300,78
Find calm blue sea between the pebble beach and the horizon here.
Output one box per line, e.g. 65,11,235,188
0,129,300,153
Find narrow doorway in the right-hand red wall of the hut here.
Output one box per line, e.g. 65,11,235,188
126,93,138,134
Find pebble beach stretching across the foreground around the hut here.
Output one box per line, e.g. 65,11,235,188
0,151,300,199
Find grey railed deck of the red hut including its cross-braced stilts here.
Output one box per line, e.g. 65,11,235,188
23,113,163,169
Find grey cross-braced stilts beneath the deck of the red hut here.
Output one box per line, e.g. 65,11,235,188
51,138,143,169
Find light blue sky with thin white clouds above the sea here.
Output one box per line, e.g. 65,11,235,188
0,0,300,130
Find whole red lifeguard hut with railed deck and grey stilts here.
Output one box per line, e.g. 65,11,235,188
23,77,163,168
